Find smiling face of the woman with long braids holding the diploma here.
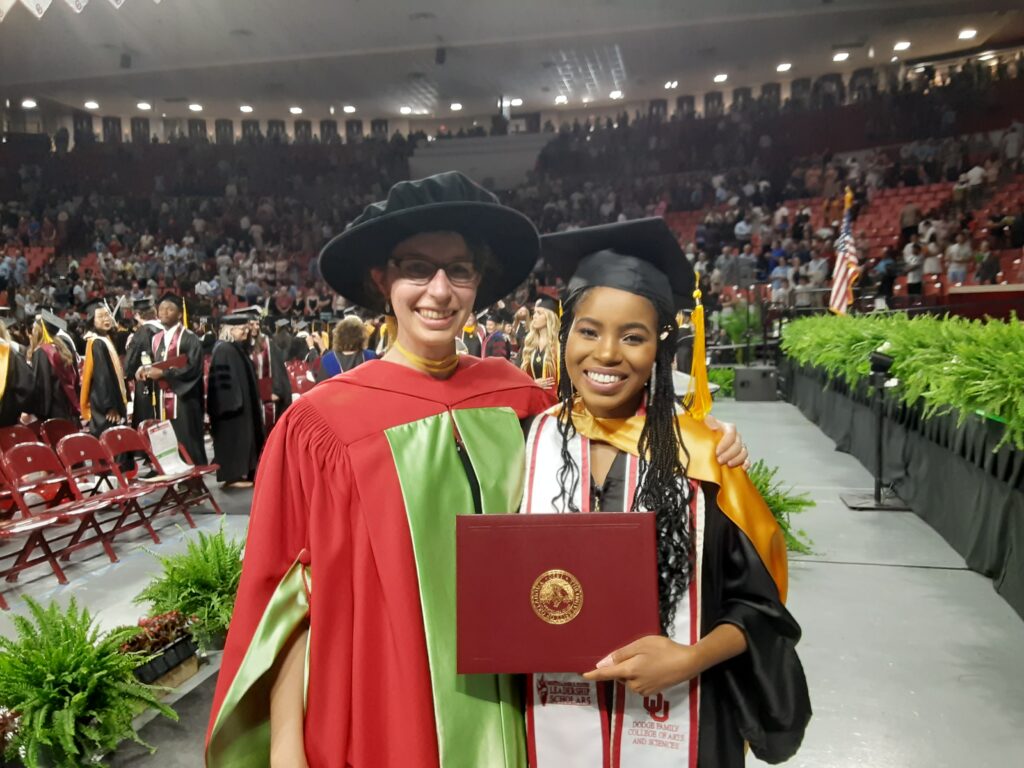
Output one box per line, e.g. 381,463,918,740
565,288,658,419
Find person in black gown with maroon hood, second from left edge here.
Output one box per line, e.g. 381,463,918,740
30,309,81,424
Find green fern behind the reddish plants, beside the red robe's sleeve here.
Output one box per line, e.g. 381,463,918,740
135,526,245,647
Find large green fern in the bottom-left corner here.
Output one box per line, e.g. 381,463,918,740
0,597,178,768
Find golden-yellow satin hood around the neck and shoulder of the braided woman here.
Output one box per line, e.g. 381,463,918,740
565,397,788,602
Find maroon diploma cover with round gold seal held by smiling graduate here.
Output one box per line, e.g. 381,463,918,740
456,512,660,675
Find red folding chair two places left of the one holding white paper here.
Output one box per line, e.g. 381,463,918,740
0,442,118,582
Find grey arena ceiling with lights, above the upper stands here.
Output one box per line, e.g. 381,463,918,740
0,0,1024,119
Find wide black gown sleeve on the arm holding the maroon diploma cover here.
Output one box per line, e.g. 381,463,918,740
708,495,811,764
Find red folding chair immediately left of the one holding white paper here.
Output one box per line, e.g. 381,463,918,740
56,432,175,544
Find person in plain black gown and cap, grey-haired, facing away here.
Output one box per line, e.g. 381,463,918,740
206,314,263,487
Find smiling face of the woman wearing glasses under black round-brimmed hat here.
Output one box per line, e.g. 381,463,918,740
371,232,479,359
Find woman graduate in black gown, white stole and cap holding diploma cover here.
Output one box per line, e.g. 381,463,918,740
520,218,811,768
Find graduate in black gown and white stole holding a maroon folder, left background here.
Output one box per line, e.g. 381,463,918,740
141,293,207,465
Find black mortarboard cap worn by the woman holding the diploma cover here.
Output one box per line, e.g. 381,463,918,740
541,218,694,318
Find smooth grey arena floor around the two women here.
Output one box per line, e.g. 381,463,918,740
0,401,1024,768
